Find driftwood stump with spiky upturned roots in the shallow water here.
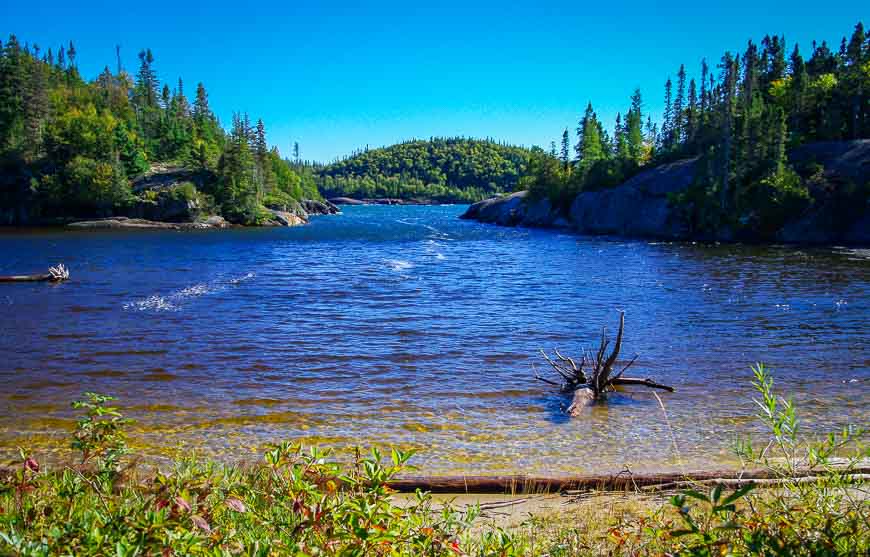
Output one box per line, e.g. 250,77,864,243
535,312,674,416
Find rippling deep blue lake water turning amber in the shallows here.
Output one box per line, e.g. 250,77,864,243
0,206,870,474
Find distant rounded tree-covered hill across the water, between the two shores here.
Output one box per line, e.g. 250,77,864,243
317,138,530,202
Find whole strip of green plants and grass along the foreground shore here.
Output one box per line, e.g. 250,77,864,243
0,365,870,557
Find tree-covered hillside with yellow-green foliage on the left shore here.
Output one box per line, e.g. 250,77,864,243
0,35,318,224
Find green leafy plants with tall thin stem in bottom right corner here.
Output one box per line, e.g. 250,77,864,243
668,364,870,556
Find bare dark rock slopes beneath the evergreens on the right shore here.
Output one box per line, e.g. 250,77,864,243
462,140,870,245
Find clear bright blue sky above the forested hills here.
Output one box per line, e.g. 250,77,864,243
0,0,870,161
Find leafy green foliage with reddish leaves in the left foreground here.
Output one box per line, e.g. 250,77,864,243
0,394,516,556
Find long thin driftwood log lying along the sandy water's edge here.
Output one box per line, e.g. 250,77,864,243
387,466,870,494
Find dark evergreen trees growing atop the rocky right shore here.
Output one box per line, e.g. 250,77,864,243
522,23,870,235
